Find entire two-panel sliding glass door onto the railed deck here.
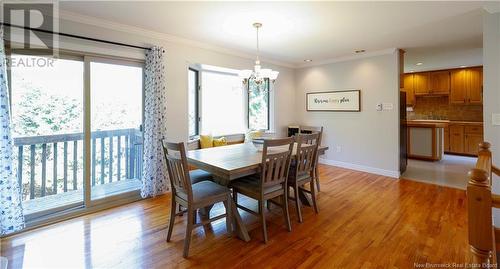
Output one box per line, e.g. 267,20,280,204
9,53,143,222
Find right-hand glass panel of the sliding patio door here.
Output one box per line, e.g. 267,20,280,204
90,58,143,200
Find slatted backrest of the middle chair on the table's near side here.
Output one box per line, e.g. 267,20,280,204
261,137,294,189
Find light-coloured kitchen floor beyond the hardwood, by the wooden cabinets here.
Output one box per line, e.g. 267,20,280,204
401,154,477,190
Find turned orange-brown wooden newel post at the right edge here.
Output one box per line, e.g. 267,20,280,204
467,142,500,268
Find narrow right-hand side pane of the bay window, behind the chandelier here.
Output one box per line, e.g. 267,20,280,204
248,79,270,130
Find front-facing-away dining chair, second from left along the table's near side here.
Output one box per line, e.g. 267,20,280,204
230,137,294,243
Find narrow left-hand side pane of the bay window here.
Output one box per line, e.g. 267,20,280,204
188,68,200,137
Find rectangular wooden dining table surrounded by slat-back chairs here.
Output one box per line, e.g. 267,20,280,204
186,143,328,242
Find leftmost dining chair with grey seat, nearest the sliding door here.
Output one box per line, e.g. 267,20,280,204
162,141,232,255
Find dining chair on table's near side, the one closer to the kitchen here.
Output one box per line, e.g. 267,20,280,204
287,133,319,222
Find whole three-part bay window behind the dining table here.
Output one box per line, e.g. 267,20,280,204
188,65,271,138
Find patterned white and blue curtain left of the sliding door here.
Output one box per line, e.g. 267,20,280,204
0,27,24,235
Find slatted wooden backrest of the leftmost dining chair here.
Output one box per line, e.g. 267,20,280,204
161,140,193,201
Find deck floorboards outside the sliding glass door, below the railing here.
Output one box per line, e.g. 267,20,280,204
23,179,141,217
